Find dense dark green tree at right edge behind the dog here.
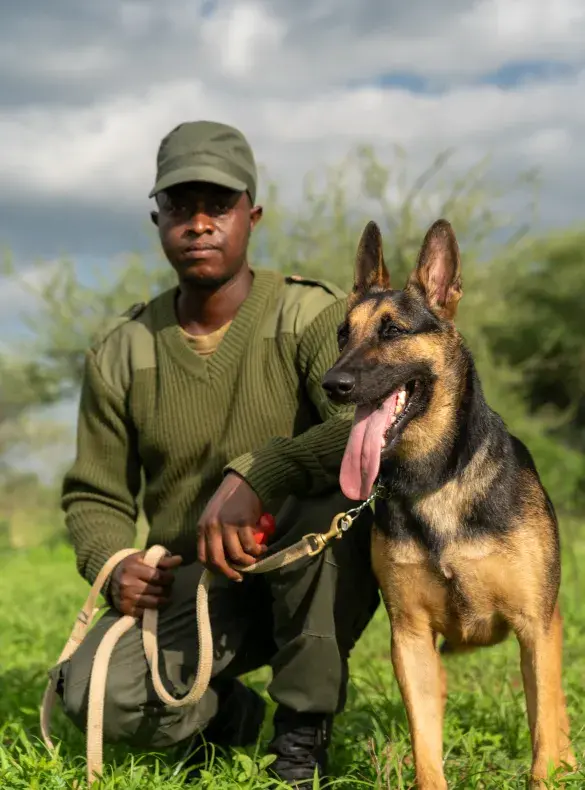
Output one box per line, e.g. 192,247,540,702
487,229,585,452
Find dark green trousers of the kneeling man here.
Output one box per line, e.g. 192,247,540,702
52,492,379,749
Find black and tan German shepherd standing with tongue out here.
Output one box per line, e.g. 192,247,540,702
323,220,575,790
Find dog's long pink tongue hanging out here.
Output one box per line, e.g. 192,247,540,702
339,392,398,499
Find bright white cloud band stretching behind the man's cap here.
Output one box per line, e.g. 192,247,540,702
0,65,585,224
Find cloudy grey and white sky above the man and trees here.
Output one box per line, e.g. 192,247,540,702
0,0,585,339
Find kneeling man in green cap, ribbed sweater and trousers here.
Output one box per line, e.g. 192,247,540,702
54,121,378,786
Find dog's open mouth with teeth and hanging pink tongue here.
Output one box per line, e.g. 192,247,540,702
339,379,421,500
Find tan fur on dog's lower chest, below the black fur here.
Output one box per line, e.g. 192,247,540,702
372,526,545,645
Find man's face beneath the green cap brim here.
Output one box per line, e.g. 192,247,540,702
152,183,262,288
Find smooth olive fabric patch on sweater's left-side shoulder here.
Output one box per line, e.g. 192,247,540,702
91,302,156,396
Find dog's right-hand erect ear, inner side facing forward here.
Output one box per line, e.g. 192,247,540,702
408,219,463,321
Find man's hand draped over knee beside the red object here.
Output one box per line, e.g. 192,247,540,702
197,472,266,582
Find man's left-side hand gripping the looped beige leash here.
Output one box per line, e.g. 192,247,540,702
110,551,183,617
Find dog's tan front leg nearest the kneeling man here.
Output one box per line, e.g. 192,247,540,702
392,623,447,790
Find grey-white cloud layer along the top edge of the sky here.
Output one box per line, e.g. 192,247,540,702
0,0,585,94
